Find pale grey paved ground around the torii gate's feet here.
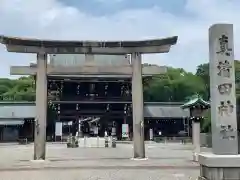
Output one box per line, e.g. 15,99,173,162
0,144,199,180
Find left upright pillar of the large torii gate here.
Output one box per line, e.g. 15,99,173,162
34,53,47,160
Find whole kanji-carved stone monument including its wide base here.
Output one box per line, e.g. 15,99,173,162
199,24,240,180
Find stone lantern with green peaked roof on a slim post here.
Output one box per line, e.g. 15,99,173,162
181,96,210,161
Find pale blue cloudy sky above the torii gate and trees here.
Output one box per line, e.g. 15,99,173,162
0,0,240,77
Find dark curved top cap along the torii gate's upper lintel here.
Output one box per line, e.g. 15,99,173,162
0,36,178,48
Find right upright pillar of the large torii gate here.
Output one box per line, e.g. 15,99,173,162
131,53,145,158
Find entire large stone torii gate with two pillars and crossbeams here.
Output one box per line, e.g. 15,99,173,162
0,36,178,160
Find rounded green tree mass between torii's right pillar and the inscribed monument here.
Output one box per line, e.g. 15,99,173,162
144,67,206,102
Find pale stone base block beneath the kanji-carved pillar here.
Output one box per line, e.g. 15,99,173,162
198,153,240,180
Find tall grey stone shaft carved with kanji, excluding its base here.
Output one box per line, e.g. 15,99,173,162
209,24,238,154
